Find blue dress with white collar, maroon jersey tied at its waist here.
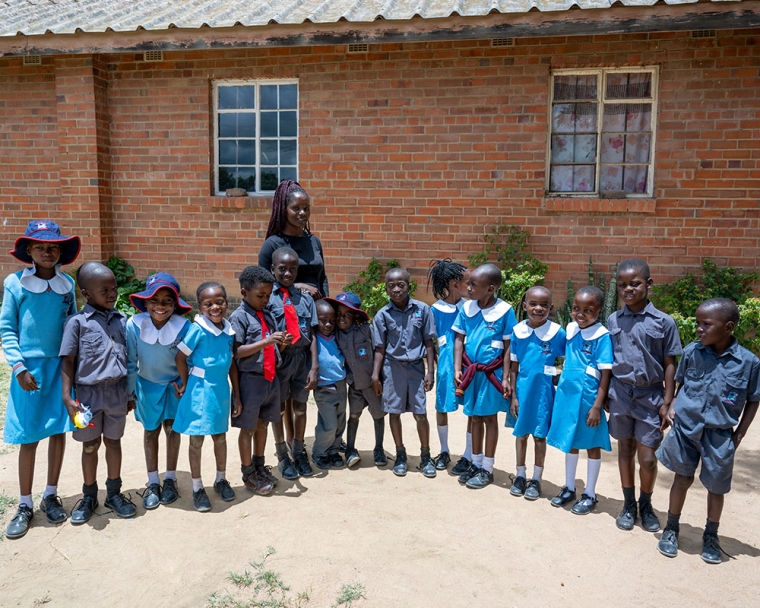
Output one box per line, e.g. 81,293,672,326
452,299,516,416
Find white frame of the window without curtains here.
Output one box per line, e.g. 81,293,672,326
212,78,301,196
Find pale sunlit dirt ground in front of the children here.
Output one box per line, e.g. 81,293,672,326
0,397,760,608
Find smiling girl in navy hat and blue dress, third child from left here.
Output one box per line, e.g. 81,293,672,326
127,272,192,510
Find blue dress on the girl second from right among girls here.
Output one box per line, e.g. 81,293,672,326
506,320,565,438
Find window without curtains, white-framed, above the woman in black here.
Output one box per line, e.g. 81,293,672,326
214,80,298,194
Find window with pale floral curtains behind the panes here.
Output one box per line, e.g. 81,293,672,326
547,68,657,198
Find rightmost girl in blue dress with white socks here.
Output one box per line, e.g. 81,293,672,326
546,286,612,515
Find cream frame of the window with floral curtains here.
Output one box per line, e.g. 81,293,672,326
545,65,659,199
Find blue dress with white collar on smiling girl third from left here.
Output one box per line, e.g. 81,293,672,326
127,312,190,431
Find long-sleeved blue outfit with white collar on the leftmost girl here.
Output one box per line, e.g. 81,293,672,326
0,267,76,444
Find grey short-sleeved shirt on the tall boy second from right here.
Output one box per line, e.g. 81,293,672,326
607,302,683,388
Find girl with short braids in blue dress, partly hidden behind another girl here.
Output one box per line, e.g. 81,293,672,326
428,258,472,474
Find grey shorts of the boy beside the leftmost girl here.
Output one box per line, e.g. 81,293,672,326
72,378,127,442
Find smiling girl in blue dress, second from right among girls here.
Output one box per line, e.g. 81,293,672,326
507,285,565,500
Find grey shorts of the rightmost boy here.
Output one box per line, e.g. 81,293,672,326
657,421,735,494
